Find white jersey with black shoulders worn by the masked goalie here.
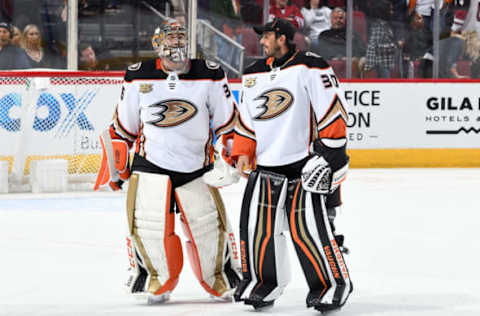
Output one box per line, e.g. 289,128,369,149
110,59,236,172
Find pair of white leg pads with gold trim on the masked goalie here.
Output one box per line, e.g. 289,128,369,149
127,172,239,296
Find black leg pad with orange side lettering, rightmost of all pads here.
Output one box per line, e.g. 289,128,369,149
287,180,352,307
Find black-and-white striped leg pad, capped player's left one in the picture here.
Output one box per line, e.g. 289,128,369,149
234,171,290,306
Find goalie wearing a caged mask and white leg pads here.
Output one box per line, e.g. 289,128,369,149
95,21,240,302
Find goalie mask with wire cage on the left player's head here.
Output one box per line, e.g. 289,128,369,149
152,20,188,64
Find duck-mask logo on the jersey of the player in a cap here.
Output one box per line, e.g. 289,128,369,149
254,89,293,120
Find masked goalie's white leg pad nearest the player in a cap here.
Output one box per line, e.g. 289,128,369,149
175,178,239,297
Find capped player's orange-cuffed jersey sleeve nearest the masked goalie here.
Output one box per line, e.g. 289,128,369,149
232,78,257,161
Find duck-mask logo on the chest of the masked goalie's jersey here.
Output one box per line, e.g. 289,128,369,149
147,100,197,127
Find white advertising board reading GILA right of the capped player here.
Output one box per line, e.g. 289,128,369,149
232,82,480,149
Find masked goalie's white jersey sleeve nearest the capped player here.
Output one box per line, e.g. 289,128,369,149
208,68,236,138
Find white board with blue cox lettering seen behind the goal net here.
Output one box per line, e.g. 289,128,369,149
0,78,123,156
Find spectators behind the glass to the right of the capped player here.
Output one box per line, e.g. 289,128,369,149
258,0,480,78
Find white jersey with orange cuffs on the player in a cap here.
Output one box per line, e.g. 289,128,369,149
232,51,348,166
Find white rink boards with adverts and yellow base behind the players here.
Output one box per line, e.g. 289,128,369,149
0,72,480,173
